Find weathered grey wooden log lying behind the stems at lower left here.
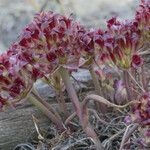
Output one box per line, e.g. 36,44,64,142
0,103,71,150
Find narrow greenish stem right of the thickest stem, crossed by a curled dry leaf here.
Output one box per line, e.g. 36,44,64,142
89,66,107,113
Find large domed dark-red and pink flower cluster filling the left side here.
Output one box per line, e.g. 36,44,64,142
0,12,85,108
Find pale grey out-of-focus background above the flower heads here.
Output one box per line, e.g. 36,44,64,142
0,0,140,53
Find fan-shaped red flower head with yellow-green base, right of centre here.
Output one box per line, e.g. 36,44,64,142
94,14,142,69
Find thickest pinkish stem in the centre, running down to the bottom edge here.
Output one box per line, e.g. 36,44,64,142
60,67,103,150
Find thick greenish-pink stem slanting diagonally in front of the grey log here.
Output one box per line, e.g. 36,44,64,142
28,96,65,131
